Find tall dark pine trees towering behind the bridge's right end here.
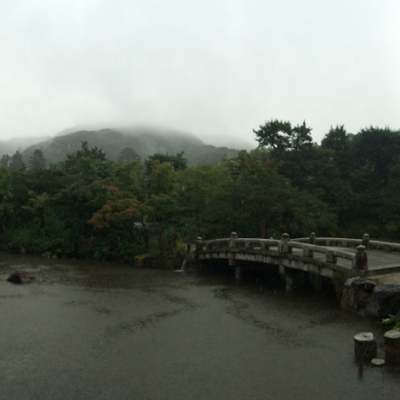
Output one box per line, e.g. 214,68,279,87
255,121,400,240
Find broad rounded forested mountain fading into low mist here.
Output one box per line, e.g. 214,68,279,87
18,126,244,166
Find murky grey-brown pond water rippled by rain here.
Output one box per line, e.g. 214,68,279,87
0,254,400,400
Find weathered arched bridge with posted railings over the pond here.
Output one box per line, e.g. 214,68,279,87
195,232,400,290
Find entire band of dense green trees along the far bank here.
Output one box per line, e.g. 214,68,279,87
0,120,400,264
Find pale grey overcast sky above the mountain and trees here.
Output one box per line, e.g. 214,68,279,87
0,0,400,147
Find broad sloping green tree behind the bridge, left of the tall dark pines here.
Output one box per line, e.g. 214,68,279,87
231,149,336,237
